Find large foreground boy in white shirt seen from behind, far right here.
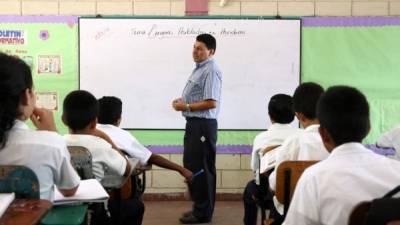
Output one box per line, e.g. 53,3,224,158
284,86,400,225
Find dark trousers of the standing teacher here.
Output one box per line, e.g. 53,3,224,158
183,117,218,220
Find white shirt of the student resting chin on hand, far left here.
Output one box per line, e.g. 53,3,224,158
0,120,80,201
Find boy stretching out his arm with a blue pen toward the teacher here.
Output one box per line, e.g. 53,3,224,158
97,96,192,181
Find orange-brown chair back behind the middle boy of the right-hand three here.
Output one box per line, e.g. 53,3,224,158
275,161,319,217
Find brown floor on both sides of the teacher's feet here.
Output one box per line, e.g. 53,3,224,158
143,201,243,225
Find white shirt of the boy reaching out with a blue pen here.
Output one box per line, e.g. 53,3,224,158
97,124,152,165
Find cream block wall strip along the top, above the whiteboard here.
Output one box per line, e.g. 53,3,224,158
0,0,400,16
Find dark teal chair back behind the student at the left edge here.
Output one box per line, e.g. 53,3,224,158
0,165,40,199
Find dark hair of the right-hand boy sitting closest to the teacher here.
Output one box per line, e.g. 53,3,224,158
268,94,294,124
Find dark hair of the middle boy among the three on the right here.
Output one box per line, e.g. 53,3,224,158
293,82,324,119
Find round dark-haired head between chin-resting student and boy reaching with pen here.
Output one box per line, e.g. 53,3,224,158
63,90,99,130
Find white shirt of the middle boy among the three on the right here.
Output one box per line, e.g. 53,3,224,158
269,124,329,190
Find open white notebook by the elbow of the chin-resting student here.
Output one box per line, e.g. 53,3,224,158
53,179,109,205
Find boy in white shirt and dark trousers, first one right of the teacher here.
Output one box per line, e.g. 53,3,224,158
243,94,299,225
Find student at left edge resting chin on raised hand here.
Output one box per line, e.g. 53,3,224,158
0,53,80,201
